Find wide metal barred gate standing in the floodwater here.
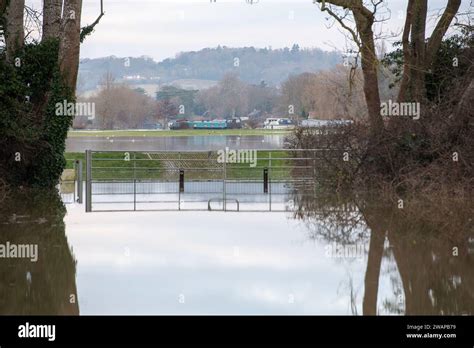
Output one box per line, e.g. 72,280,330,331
86,150,330,212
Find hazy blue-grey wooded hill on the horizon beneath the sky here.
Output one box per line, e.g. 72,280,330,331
78,44,342,92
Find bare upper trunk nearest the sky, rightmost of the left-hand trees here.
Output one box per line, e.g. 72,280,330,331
59,0,82,93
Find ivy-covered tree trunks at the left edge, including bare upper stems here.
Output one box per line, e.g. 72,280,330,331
0,0,93,188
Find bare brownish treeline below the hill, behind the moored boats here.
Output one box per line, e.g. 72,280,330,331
74,65,374,129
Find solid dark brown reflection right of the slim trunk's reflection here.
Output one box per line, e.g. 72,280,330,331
387,207,474,314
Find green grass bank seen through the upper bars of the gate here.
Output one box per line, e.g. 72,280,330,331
63,151,291,181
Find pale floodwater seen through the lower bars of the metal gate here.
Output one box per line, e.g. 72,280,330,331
88,180,294,212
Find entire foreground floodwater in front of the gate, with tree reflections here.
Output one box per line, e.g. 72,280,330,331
0,192,474,315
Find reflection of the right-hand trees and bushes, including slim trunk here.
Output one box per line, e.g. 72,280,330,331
294,189,474,315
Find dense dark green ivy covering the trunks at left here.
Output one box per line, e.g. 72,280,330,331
0,39,75,188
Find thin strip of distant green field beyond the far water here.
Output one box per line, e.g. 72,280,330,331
68,129,290,138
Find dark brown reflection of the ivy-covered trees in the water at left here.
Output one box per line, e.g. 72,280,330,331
0,191,79,315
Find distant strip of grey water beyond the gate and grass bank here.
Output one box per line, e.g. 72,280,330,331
66,134,285,152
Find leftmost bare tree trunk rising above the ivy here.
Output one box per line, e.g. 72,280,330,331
4,0,25,62
